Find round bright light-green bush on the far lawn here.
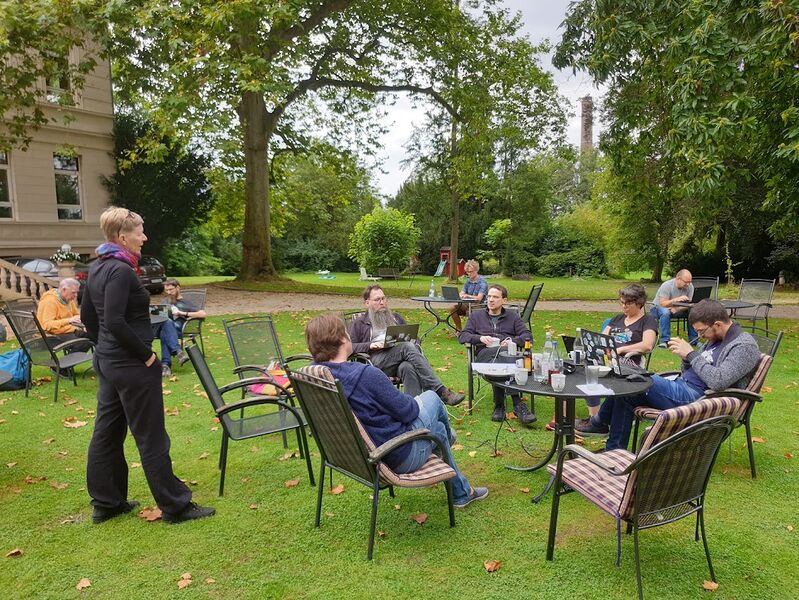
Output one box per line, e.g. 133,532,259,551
349,207,421,272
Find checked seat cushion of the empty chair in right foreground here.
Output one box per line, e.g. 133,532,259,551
547,449,635,518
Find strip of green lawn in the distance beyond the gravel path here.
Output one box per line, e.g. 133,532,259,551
212,273,799,304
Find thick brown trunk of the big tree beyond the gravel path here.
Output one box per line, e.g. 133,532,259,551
239,92,277,279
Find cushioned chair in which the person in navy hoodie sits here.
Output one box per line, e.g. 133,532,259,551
289,365,455,560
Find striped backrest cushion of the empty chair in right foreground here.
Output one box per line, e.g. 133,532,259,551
618,396,745,519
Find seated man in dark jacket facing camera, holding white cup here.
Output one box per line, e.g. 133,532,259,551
458,284,536,424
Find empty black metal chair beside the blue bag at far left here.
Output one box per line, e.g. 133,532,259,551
4,310,94,402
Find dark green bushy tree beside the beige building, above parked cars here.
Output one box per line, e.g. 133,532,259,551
104,113,213,257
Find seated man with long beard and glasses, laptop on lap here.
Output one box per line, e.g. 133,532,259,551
350,285,466,406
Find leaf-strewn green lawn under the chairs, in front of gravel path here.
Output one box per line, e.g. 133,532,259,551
0,310,799,600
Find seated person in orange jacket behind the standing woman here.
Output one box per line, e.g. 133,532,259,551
36,277,92,352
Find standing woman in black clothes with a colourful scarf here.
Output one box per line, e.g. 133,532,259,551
80,207,215,523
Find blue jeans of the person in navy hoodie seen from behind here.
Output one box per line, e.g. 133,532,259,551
394,391,470,502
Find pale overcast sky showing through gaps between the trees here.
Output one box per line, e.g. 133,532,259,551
374,0,598,196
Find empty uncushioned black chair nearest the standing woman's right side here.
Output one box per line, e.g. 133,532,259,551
186,344,315,496
